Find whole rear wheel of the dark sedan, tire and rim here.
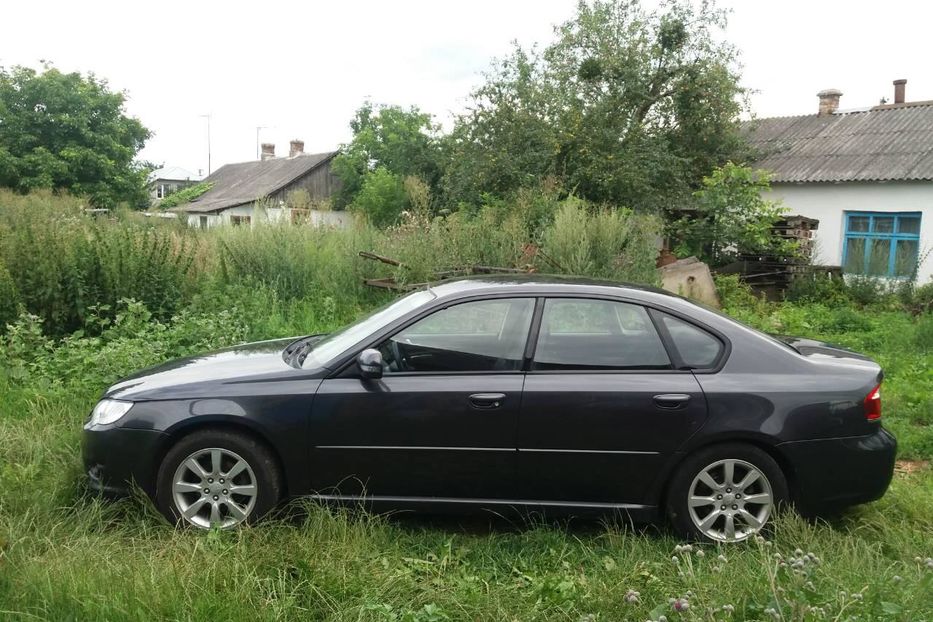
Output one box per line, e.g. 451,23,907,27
667,444,788,542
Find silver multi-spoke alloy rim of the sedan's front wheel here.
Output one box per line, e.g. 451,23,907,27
172,447,259,529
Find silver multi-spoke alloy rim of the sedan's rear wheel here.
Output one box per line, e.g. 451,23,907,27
687,459,774,542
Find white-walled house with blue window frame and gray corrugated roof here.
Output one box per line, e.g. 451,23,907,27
747,80,933,282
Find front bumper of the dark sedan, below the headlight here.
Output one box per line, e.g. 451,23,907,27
82,426,166,496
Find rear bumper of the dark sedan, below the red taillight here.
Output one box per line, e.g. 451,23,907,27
778,426,897,513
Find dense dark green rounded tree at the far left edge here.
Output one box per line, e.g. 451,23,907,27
0,66,150,208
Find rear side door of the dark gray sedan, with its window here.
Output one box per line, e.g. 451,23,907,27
519,298,706,504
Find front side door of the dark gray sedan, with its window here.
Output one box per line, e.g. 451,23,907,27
310,298,535,499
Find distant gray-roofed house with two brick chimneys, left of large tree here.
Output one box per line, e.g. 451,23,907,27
171,140,348,227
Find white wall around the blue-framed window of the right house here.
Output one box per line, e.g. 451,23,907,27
769,182,933,283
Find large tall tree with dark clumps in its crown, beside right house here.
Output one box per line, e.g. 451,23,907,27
443,0,743,209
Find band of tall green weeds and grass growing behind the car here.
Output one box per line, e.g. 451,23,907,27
0,191,658,335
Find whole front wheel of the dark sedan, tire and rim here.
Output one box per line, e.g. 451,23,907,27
156,430,282,529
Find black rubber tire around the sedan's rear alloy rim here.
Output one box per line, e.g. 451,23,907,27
665,443,790,542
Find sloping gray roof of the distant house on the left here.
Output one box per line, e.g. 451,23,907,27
171,151,337,214
